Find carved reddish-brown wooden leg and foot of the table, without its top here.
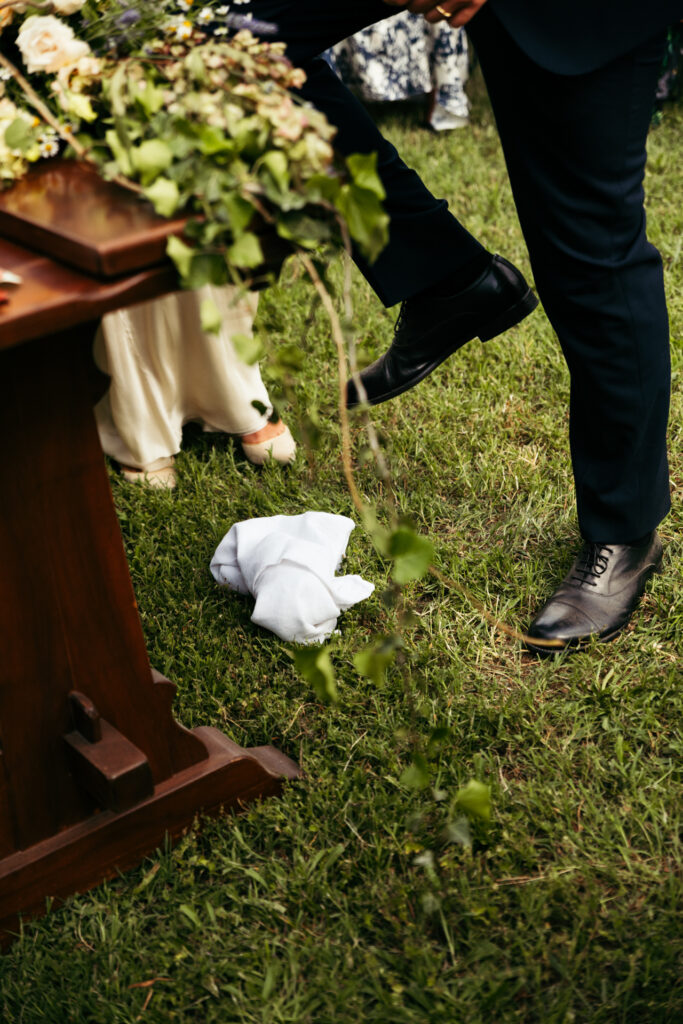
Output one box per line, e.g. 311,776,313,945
0,324,298,930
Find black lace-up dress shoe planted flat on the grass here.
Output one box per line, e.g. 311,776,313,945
526,532,661,654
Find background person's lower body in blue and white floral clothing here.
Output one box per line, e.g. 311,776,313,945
325,11,469,131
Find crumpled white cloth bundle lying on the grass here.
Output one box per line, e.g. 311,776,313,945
211,512,375,643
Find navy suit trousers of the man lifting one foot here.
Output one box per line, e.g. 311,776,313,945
250,0,671,543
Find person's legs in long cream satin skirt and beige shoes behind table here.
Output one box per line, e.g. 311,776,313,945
95,286,296,487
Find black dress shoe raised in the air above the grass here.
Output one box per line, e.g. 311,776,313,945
346,256,539,409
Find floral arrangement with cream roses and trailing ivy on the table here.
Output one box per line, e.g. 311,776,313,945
0,0,388,288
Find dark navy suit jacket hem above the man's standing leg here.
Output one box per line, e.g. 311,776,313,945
489,0,683,75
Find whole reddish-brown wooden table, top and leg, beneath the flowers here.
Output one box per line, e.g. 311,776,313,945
0,165,298,939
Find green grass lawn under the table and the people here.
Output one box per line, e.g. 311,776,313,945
0,75,683,1024
